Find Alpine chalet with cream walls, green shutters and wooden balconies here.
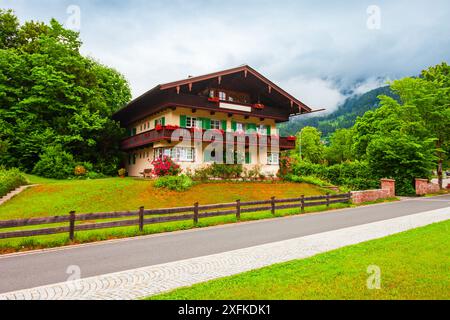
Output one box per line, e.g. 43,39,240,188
113,66,311,176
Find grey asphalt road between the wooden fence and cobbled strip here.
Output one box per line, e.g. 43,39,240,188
0,196,450,293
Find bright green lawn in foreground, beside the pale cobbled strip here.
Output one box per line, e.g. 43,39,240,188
152,221,450,300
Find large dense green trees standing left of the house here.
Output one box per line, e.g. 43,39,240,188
0,10,131,178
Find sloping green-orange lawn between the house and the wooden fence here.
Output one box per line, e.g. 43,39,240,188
0,176,324,220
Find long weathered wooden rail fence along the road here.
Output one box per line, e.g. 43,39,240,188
0,193,351,240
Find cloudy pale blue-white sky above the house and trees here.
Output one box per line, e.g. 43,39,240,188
0,0,450,110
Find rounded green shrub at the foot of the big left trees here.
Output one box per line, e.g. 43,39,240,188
33,145,75,180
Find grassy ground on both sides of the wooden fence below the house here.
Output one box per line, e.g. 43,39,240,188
0,176,342,254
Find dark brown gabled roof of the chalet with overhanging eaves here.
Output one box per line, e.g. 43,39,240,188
113,65,313,124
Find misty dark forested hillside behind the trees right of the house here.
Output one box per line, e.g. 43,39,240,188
280,86,395,138
